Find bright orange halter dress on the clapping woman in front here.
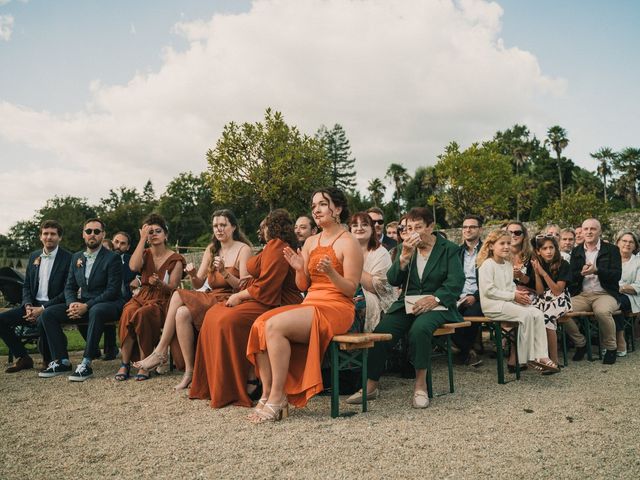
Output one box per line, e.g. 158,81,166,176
247,234,355,407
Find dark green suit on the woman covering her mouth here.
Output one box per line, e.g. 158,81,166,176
369,235,464,381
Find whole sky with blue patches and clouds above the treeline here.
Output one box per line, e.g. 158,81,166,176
0,0,640,234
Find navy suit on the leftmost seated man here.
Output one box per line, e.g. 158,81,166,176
0,247,71,361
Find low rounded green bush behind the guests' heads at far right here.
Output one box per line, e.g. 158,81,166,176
538,192,609,230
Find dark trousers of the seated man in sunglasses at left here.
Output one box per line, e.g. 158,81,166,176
38,301,122,360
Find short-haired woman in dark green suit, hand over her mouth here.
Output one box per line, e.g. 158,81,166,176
347,207,464,408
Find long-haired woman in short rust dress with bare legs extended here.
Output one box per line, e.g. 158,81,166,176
135,209,251,390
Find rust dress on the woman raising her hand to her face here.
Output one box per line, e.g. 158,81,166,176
120,248,187,361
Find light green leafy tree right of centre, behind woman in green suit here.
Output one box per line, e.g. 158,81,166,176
436,142,515,223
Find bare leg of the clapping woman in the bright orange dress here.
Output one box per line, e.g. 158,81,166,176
266,307,314,405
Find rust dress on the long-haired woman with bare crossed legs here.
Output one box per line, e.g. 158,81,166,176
170,246,249,370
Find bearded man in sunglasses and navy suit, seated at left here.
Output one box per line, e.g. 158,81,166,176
38,218,122,382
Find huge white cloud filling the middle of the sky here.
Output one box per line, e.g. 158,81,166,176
0,0,565,229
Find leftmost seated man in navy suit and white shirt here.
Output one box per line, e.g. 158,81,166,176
0,220,71,373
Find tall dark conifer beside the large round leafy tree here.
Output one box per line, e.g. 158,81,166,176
316,123,356,192
